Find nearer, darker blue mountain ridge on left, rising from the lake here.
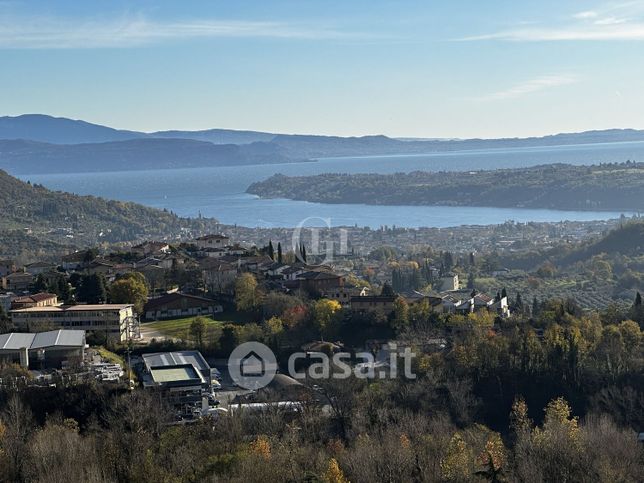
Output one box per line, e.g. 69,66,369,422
0,138,304,174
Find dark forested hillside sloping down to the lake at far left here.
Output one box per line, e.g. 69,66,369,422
0,170,216,255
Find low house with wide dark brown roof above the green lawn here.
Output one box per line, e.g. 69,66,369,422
143,293,223,320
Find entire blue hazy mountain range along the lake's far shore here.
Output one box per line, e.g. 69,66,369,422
0,114,644,174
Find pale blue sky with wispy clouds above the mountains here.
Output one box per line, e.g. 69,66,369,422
0,0,644,138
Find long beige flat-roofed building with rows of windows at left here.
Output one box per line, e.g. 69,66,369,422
11,304,134,341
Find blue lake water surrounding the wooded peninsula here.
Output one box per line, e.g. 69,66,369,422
20,142,644,228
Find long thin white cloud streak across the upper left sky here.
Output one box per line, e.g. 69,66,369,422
0,16,365,49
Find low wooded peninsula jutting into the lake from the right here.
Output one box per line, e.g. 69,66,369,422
247,162,644,211
